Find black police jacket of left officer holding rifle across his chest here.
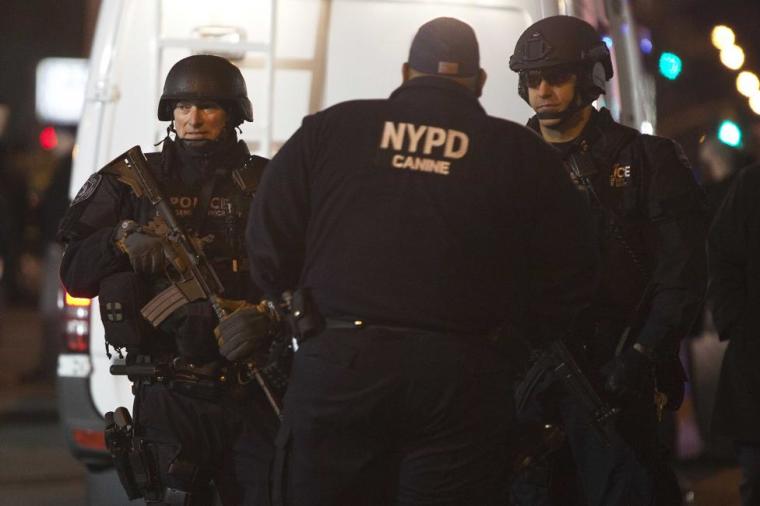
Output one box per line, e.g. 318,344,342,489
58,140,260,358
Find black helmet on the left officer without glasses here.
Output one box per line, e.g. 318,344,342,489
158,54,253,125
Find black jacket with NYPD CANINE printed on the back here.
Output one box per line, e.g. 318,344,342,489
247,77,597,342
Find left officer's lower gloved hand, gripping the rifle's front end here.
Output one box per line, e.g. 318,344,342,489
214,304,277,364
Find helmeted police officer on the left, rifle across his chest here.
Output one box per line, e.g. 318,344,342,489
59,55,277,505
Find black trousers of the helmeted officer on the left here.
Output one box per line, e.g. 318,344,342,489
134,384,278,506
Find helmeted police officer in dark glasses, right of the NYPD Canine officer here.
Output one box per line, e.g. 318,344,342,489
509,16,705,506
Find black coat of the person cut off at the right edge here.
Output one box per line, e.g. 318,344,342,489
708,165,760,442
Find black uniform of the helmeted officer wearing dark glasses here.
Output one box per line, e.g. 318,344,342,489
529,109,705,505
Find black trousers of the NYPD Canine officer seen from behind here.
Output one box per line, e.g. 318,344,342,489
275,327,513,506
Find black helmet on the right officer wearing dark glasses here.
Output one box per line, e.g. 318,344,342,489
509,16,612,104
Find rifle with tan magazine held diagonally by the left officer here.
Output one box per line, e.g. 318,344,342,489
101,146,281,416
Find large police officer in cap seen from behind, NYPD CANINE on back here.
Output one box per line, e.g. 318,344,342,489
218,18,596,506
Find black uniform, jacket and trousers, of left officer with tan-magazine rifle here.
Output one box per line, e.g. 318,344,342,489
60,139,276,505
